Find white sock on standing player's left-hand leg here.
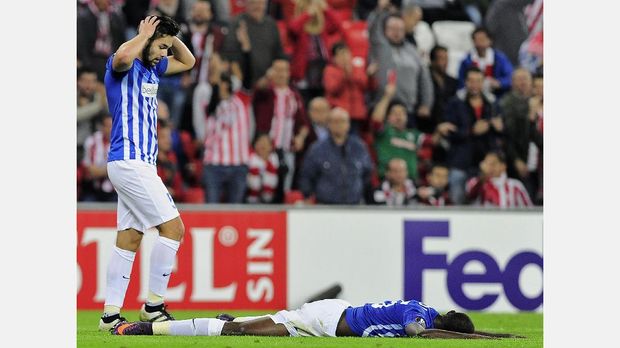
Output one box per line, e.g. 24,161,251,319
104,246,136,315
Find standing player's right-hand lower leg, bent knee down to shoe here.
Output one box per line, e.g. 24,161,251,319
140,216,185,322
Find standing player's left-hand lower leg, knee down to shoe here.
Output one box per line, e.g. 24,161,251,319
99,228,143,330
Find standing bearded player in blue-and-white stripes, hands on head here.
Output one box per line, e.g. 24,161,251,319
99,16,195,330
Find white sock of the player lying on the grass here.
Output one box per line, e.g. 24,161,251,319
159,318,226,336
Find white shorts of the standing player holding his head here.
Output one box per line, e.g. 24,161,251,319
108,160,179,232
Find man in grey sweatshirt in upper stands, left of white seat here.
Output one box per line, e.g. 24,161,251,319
368,0,433,128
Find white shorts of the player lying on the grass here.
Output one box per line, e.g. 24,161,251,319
270,299,351,337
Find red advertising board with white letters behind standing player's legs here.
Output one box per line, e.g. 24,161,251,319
77,211,287,309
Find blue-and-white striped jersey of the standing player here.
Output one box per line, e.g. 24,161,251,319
104,55,168,165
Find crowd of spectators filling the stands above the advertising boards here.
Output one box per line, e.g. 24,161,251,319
77,0,543,207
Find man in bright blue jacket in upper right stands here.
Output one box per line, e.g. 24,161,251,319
459,28,513,102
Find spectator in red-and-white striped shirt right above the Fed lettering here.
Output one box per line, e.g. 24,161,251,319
467,151,533,208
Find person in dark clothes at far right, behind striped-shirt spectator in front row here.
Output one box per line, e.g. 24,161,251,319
499,68,534,194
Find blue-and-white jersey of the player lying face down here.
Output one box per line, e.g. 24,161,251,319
345,300,439,337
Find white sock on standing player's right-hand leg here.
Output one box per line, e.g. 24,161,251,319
146,236,181,306
